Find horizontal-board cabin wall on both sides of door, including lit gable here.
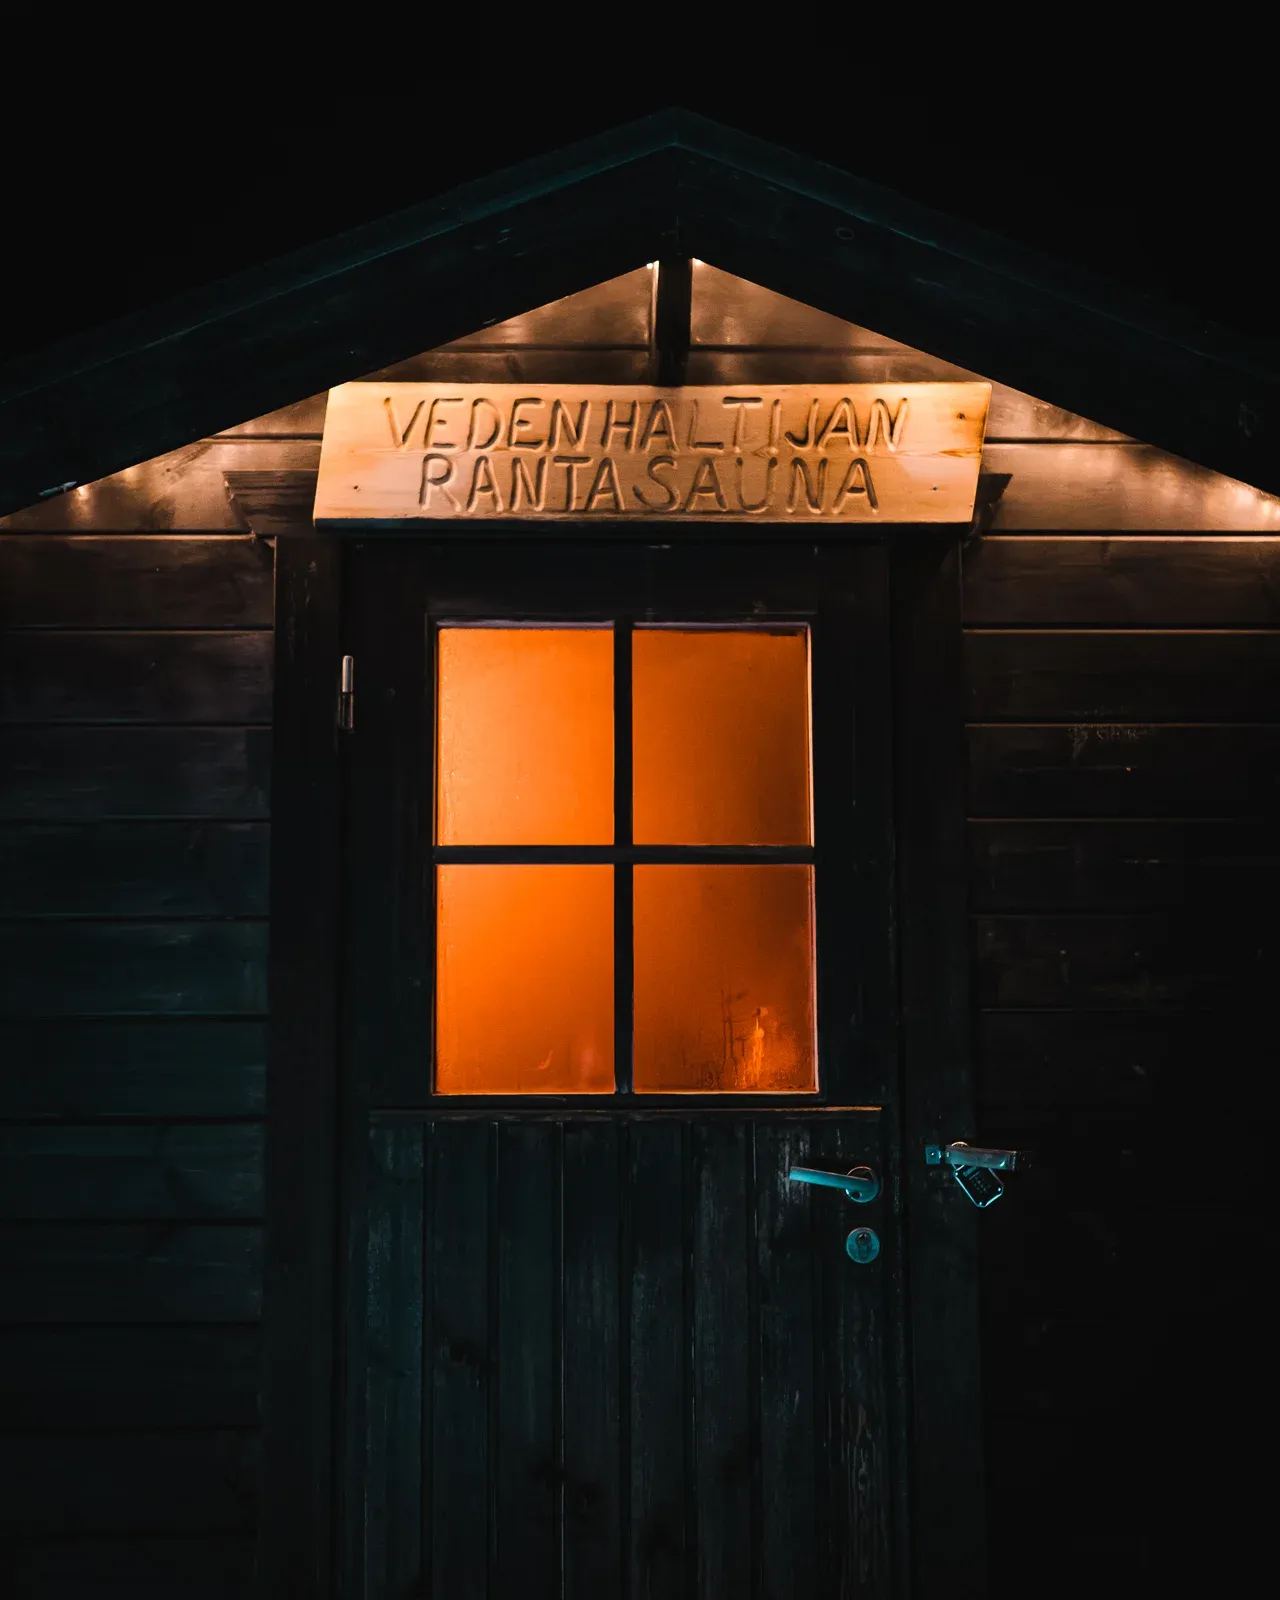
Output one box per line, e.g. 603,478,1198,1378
0,267,1280,1600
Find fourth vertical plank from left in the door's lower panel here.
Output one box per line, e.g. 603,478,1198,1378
560,1122,622,1600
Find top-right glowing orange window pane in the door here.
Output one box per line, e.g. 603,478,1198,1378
632,627,810,845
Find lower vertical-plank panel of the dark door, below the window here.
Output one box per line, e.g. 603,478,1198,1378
352,1107,896,1600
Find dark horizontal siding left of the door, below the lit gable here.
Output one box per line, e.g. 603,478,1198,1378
0,534,272,1597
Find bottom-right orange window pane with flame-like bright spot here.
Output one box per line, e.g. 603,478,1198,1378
635,864,816,1093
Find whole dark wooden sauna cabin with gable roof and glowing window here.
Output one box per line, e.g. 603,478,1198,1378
0,117,1280,1600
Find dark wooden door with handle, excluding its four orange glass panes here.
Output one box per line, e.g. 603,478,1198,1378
341,542,906,1600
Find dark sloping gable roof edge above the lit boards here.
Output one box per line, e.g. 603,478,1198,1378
0,110,1280,515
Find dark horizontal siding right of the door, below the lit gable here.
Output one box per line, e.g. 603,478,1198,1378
963,531,1280,1597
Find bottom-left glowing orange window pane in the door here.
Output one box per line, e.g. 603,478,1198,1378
435,864,613,1094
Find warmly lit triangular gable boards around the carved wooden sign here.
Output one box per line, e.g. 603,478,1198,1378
0,262,1280,533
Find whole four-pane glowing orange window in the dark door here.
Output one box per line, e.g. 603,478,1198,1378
435,624,818,1094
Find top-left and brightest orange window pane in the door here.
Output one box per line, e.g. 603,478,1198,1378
435,627,613,845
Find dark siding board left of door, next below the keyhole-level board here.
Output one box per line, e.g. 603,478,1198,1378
0,1326,262,1430
